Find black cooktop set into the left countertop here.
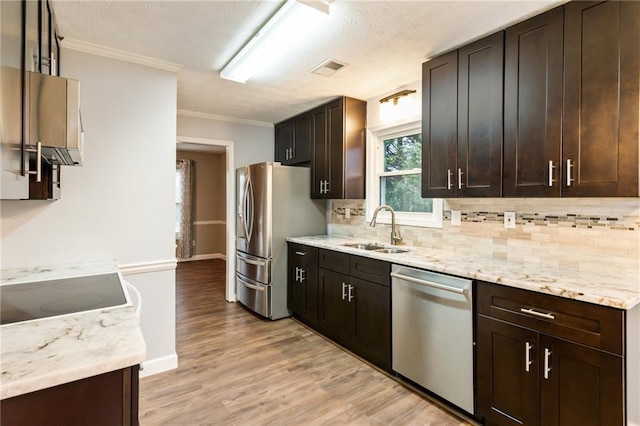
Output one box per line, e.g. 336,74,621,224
0,273,127,324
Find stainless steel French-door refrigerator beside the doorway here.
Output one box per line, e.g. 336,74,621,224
236,163,326,320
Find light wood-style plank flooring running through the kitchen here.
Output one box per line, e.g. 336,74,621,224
140,260,468,426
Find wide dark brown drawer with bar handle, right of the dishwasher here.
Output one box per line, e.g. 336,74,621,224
476,281,624,355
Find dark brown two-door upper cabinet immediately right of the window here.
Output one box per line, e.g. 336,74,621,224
422,32,504,198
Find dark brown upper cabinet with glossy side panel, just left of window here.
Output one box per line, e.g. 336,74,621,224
311,97,367,199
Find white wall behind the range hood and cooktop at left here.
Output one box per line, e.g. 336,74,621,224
0,50,176,374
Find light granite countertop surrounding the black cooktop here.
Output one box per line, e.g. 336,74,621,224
0,261,146,399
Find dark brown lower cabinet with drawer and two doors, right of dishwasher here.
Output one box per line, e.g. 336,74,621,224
476,282,626,426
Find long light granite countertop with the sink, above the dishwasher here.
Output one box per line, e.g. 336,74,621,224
287,235,640,310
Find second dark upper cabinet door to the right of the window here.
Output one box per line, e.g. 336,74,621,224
455,31,504,197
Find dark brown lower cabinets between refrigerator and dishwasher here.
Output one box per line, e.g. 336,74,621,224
289,243,391,371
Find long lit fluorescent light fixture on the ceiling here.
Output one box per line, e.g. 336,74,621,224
220,0,329,83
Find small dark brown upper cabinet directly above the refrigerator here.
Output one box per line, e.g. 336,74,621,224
275,112,311,165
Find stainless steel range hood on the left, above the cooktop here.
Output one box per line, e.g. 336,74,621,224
24,72,82,166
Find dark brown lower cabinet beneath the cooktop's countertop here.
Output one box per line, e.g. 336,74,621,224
0,365,139,426
